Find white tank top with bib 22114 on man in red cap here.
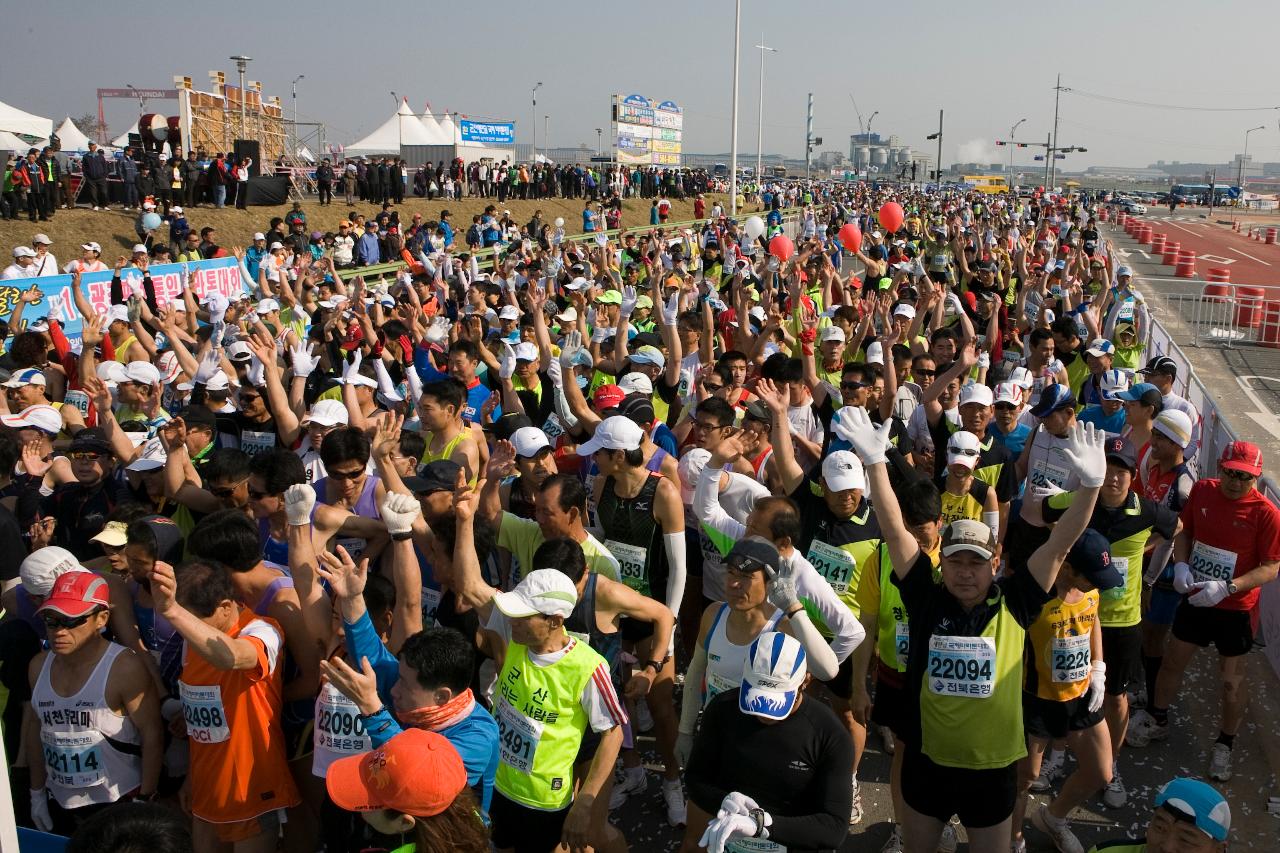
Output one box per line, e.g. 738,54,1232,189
31,643,142,808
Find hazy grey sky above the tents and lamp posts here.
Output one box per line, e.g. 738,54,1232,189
0,0,1280,169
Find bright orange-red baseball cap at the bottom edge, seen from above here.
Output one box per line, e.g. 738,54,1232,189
325,729,467,817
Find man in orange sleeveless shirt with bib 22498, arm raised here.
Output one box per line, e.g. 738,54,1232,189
151,561,300,853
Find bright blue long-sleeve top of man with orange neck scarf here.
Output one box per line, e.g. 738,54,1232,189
343,613,498,821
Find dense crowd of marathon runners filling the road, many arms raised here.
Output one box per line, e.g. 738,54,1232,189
0,183,1264,853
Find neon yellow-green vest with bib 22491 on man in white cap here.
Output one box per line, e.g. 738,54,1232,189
493,640,605,812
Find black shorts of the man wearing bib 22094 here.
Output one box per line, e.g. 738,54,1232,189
902,744,1018,829
